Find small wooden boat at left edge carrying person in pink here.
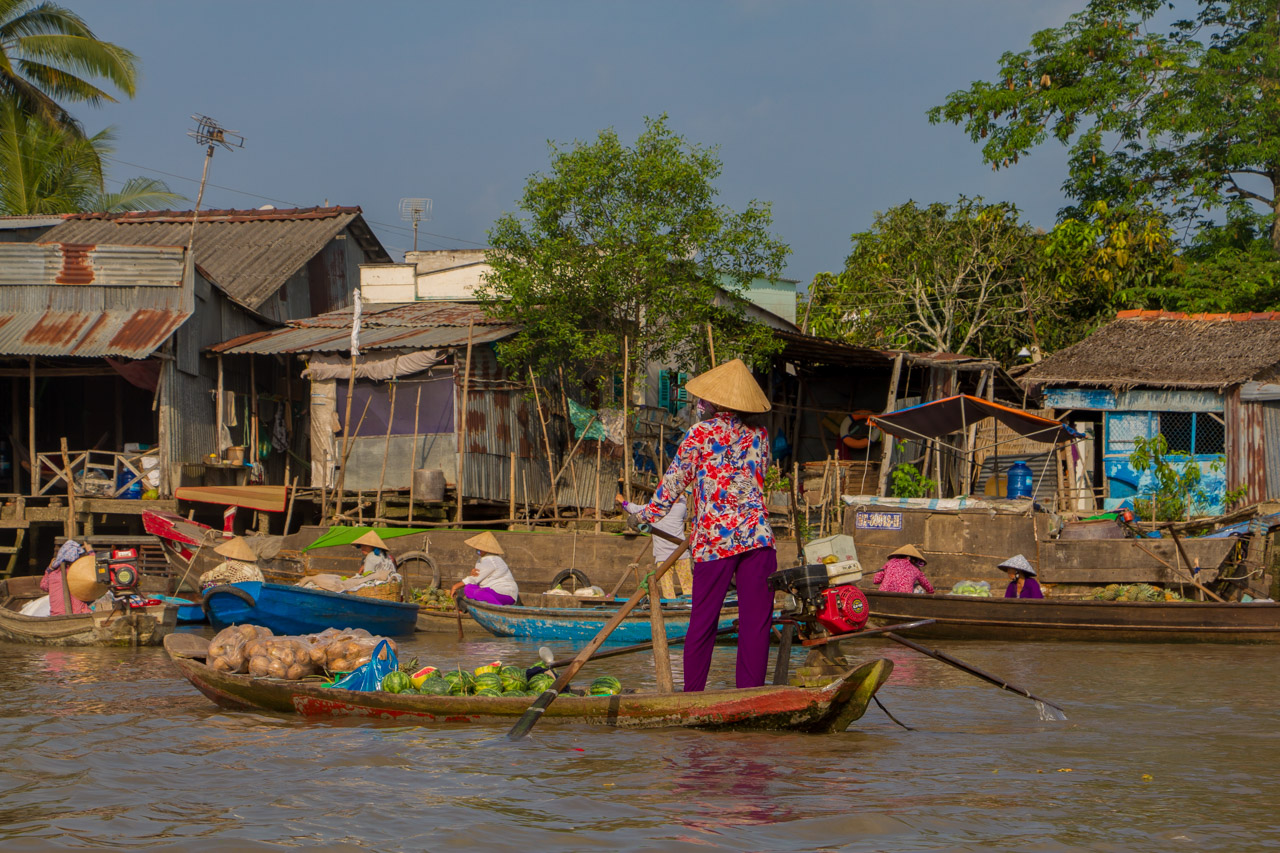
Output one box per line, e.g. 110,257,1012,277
0,578,178,646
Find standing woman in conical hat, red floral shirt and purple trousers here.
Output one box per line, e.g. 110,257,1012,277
636,359,778,693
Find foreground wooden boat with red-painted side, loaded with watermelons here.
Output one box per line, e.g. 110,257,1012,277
165,637,893,734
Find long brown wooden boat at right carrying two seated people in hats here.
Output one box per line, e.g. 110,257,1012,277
864,589,1280,643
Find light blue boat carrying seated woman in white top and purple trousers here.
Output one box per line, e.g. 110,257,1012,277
465,599,737,643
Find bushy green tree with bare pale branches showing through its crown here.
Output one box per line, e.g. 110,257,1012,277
806,197,1052,357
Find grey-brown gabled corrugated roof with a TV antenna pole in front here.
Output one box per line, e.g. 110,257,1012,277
45,207,390,309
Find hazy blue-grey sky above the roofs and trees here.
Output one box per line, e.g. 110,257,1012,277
87,0,1084,284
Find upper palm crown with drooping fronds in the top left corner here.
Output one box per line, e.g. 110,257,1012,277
0,0,138,134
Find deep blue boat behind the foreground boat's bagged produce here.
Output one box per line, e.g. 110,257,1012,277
205,581,417,637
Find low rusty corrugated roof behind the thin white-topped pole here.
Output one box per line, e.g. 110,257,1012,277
210,302,517,355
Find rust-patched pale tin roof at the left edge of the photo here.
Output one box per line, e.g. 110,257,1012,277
0,243,193,359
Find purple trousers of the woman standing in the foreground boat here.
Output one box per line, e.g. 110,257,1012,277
685,548,778,693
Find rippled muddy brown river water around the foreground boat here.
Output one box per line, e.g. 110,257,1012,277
0,634,1280,853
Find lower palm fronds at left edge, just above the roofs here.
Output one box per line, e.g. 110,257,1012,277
0,99,183,216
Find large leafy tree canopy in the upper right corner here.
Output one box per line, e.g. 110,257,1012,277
929,0,1280,251
